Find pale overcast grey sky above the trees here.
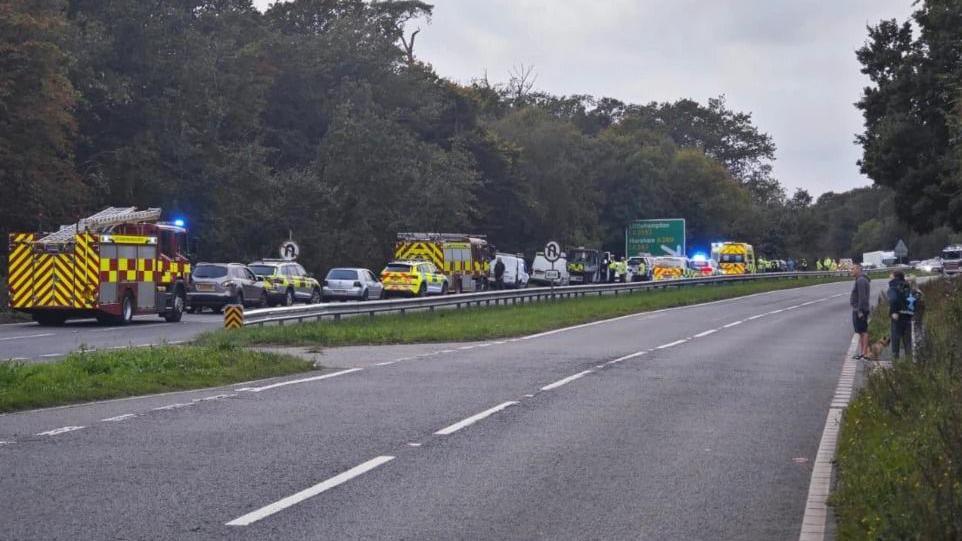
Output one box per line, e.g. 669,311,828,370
255,0,912,196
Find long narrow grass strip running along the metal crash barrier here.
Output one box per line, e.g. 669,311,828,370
197,278,848,347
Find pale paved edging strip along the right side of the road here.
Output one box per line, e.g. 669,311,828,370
798,334,858,541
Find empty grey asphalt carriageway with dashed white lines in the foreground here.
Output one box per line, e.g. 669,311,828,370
0,283,852,540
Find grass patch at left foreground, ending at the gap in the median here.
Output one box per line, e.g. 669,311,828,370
0,346,313,412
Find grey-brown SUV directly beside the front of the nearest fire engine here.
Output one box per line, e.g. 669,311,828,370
187,263,268,312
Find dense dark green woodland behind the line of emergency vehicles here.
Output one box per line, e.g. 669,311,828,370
0,0,948,271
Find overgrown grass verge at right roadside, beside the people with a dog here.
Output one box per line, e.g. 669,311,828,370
831,280,962,539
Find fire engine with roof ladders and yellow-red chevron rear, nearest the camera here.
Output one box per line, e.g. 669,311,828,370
7,207,190,325
